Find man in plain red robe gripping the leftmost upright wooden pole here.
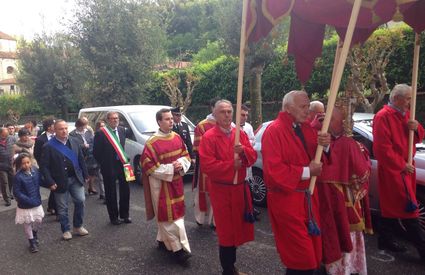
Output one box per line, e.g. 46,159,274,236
199,100,257,275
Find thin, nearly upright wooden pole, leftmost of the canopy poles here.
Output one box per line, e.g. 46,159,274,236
233,0,248,184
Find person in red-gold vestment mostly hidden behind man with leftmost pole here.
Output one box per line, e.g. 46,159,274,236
193,98,218,227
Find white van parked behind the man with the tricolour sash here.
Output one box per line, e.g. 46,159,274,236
78,105,195,181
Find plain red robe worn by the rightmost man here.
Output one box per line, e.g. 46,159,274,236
373,105,424,219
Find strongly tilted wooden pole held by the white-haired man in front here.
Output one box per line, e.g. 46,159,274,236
309,0,362,194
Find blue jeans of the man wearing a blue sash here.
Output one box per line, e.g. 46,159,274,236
54,177,86,232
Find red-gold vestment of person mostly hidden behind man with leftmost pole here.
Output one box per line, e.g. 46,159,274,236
192,118,215,212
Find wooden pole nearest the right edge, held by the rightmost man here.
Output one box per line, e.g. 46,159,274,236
408,33,421,164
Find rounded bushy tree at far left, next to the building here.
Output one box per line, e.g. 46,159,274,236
17,34,85,119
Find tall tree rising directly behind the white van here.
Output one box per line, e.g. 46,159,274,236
72,0,165,105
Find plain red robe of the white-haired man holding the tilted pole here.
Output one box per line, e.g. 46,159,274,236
261,112,322,270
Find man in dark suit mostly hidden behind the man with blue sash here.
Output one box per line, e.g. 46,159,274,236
34,118,57,214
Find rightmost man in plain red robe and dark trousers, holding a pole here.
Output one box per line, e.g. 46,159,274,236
373,84,425,261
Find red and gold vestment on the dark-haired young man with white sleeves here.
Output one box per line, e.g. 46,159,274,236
141,132,190,222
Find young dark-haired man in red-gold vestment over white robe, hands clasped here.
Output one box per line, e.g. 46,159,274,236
141,108,191,264
